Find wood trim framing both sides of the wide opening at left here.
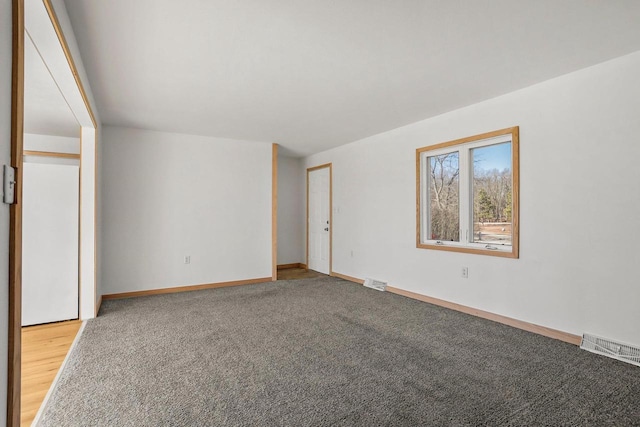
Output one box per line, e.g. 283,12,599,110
6,0,98,427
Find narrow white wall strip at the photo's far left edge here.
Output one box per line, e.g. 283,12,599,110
0,0,12,426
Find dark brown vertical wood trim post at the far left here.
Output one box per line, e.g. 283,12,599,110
6,0,24,427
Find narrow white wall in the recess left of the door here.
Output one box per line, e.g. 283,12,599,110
278,156,306,264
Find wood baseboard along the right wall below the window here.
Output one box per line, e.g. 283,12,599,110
332,273,582,345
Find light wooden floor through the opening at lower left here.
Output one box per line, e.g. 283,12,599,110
20,320,82,426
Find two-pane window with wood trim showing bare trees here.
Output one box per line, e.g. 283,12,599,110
416,127,519,258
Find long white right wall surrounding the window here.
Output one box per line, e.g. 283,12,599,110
305,52,640,345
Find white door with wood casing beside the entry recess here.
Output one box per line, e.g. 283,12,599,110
307,167,331,274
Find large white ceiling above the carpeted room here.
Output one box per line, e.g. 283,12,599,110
65,0,640,155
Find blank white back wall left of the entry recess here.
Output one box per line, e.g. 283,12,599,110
102,127,271,294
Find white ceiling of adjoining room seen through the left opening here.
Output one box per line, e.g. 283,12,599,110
24,33,80,138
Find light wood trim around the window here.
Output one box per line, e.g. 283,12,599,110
416,126,520,258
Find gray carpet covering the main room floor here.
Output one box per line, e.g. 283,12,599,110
40,278,640,426
